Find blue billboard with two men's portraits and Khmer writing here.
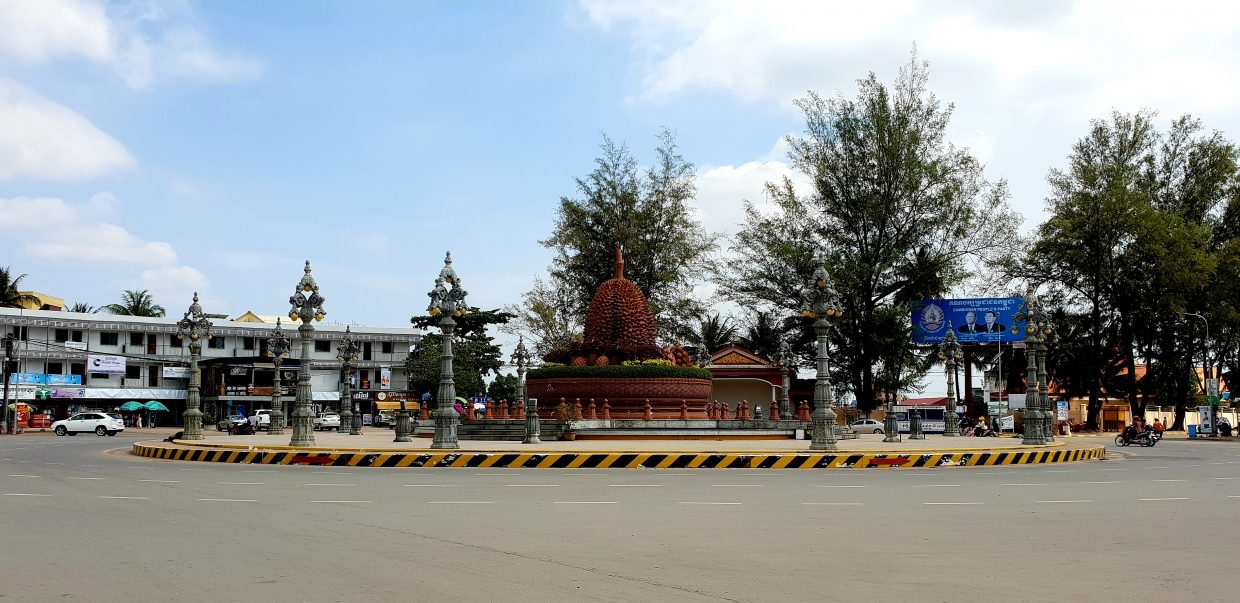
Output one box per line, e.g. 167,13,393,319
913,298,1024,344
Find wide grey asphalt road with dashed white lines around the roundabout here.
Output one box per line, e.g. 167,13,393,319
0,434,1240,602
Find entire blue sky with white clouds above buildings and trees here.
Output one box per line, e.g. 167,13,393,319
0,0,1240,382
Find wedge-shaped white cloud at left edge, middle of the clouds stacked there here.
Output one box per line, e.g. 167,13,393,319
0,78,135,180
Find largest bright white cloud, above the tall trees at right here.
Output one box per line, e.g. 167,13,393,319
574,0,1240,226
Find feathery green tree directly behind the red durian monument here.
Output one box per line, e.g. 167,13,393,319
542,130,714,341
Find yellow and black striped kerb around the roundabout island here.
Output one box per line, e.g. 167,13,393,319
134,443,1106,469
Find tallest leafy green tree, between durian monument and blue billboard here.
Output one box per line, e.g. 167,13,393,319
717,56,1019,412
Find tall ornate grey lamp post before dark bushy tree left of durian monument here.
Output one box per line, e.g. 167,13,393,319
424,252,467,449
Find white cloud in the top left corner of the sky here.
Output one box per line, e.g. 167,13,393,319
0,0,263,88
